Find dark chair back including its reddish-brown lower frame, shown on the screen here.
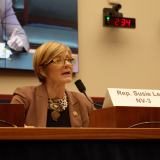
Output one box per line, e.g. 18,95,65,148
24,0,77,29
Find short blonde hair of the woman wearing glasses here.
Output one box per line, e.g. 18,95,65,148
33,42,72,83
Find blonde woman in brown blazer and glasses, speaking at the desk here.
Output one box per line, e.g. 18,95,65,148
11,42,94,127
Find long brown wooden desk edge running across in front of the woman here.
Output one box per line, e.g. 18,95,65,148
0,127,160,140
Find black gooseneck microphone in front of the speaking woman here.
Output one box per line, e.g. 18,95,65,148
75,79,102,107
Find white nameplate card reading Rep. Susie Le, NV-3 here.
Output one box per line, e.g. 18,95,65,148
102,88,160,108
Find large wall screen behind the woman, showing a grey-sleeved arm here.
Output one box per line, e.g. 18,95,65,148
0,0,79,73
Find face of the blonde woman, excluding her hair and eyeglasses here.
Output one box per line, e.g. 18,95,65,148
45,51,72,85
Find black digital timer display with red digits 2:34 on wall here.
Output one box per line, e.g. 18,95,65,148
104,16,136,28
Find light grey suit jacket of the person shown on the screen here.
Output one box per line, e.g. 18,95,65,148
0,0,29,51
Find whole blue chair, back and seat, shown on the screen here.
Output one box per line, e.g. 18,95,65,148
23,0,78,51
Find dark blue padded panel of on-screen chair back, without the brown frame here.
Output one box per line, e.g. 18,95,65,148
28,0,77,23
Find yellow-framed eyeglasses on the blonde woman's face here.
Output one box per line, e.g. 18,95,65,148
45,57,76,67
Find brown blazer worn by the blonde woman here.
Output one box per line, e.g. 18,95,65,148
11,84,95,127
